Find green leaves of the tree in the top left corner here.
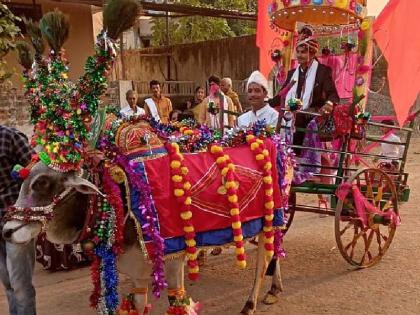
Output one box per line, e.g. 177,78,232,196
0,3,20,83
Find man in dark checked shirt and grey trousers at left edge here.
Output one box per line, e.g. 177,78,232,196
0,125,36,315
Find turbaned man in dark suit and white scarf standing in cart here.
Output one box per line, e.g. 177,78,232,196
269,29,340,151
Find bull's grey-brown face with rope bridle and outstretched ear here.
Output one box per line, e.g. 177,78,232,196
3,162,99,244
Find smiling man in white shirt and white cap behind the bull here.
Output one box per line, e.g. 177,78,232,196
238,71,279,128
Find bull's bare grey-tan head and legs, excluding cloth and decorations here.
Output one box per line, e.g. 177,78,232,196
3,162,282,314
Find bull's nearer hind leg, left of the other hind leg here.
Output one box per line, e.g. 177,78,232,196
241,233,268,315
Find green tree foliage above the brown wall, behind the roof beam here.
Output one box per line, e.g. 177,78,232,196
152,0,255,46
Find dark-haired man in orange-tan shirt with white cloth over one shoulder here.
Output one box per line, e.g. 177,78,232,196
144,80,172,124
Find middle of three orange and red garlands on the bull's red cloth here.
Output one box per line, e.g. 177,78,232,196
210,144,246,269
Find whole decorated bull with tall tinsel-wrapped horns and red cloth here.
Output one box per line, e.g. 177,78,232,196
3,0,283,314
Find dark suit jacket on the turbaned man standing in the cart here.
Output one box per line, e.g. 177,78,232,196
268,63,340,108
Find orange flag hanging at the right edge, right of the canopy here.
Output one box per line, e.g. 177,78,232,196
373,0,420,126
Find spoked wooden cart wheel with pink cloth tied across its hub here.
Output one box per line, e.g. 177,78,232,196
335,168,398,268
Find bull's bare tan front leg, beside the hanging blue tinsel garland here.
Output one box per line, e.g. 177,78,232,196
118,246,151,314
